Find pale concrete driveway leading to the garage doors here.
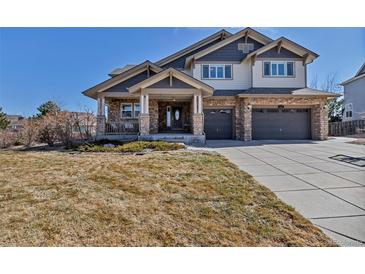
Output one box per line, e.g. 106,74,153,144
207,138,365,246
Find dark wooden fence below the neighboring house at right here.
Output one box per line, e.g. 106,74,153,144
328,119,365,136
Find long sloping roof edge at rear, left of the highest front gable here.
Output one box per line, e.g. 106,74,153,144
156,29,232,66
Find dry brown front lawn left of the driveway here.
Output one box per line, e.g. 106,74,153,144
0,151,334,246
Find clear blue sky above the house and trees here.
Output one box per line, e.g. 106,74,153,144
0,28,365,115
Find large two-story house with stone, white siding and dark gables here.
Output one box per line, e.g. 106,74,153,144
83,28,338,143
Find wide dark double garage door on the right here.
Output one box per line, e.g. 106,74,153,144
252,108,311,140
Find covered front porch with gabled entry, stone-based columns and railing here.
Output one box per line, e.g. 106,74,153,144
97,67,211,143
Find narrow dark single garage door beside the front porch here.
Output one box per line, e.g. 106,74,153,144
204,109,233,140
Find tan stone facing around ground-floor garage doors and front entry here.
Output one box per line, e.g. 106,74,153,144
97,96,328,141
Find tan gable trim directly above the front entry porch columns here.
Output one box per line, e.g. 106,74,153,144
128,68,214,95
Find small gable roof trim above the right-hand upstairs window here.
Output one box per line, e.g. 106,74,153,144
242,37,319,64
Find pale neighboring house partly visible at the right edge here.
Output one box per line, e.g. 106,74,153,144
341,63,365,121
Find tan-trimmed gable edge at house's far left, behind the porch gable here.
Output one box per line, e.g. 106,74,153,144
82,60,162,99
